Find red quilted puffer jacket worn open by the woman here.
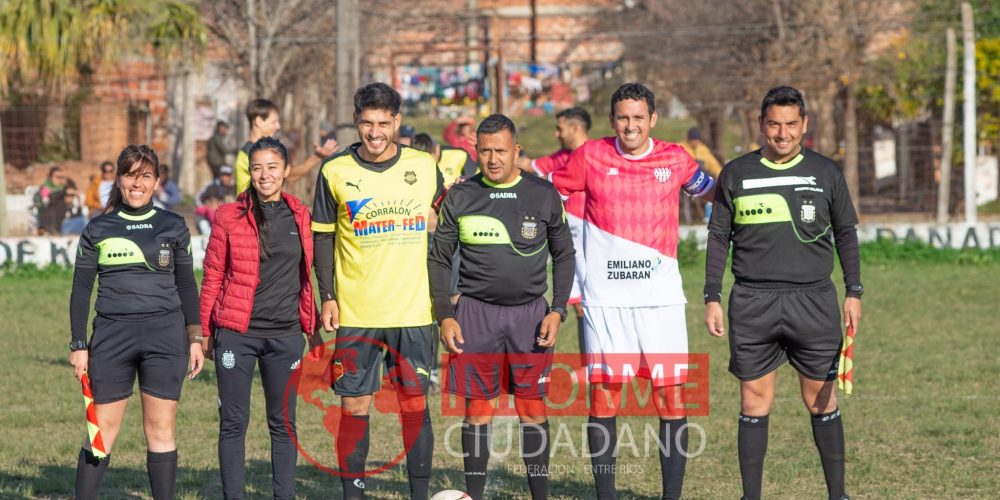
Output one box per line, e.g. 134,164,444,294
201,192,317,336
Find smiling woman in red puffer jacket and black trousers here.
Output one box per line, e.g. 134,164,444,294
201,137,322,499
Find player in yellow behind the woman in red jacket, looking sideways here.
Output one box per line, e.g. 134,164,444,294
234,99,337,194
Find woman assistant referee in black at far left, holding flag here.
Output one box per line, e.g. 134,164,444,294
69,145,205,499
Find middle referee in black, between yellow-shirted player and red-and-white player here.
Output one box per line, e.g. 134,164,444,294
429,114,575,499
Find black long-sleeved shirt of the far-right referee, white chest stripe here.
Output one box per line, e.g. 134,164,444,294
705,148,861,299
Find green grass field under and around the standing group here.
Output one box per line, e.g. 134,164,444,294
0,248,1000,498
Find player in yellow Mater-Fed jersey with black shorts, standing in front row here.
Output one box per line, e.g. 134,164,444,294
312,83,444,499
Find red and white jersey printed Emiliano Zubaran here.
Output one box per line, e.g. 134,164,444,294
550,137,698,307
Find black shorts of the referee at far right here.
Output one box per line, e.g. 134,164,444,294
729,280,842,381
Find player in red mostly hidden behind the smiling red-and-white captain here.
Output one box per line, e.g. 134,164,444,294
531,107,590,324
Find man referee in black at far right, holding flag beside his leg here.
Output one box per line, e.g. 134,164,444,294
705,87,864,500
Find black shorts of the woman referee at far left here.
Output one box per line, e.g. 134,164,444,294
87,311,189,404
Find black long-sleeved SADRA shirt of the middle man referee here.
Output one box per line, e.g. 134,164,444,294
428,173,575,321
